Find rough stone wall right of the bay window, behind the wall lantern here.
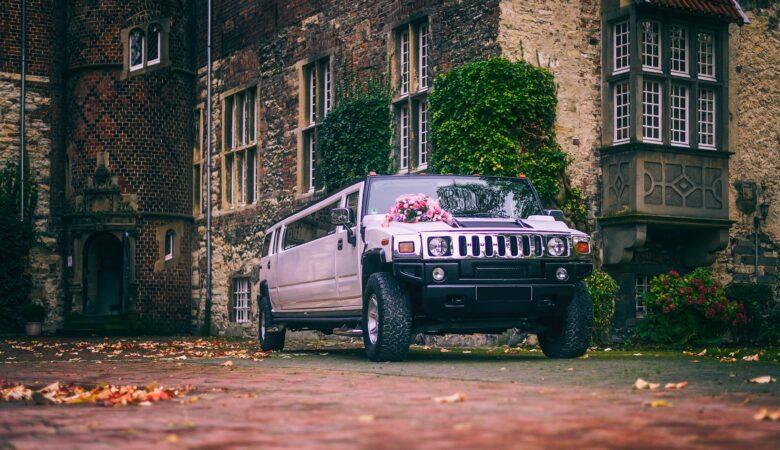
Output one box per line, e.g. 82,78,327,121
715,2,780,292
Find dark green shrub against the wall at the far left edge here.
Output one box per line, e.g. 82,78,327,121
0,165,37,331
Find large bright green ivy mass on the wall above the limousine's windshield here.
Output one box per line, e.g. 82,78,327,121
429,58,585,229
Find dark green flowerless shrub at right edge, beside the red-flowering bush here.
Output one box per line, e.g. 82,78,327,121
726,283,780,345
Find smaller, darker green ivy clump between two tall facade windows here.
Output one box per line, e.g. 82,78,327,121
318,77,393,191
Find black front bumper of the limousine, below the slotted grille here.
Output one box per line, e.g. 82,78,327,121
393,259,593,320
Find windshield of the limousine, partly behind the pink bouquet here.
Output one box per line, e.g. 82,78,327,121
366,176,543,218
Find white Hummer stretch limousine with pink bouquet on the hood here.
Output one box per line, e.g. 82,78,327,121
258,175,593,361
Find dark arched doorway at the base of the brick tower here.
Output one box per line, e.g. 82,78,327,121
84,232,123,315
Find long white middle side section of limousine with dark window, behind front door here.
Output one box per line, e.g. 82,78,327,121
276,202,339,312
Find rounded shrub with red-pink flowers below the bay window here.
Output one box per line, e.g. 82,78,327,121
637,268,747,345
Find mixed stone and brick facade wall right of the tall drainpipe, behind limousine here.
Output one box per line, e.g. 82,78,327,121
193,0,500,335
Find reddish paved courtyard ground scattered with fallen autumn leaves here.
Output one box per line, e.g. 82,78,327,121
0,337,780,450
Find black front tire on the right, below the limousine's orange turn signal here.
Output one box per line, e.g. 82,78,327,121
538,281,593,358
